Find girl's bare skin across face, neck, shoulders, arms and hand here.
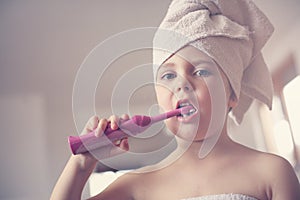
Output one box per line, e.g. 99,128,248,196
51,47,300,200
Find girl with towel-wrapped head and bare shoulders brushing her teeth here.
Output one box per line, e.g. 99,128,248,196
52,0,300,200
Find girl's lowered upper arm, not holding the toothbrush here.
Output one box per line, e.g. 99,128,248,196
270,157,300,200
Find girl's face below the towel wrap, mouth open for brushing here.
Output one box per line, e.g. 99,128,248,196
155,46,230,141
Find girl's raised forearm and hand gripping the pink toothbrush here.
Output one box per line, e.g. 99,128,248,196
51,115,129,200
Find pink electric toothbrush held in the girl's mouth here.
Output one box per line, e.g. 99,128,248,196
68,106,193,155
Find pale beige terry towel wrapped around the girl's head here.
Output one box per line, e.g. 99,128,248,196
153,0,274,123
